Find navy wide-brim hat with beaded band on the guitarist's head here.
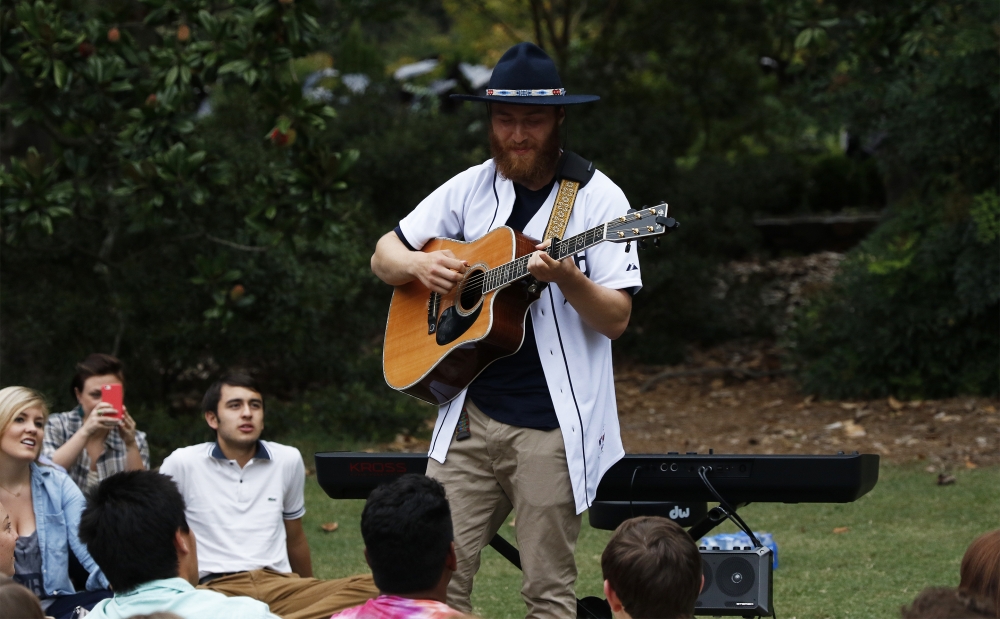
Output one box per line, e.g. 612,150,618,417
451,43,600,105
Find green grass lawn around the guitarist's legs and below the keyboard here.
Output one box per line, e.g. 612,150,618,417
303,450,1000,619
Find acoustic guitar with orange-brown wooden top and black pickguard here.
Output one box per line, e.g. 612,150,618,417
382,204,679,405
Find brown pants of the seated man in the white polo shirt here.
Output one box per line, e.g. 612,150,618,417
199,569,378,619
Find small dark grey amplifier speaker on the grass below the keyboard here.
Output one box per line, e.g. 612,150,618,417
694,547,773,617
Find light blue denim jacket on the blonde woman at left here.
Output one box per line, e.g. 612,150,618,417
31,462,110,597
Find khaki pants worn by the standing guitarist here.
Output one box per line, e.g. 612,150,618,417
427,399,580,619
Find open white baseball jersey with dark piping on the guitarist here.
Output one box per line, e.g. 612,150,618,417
399,159,642,513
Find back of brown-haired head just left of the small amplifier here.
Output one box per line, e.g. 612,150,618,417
601,516,705,619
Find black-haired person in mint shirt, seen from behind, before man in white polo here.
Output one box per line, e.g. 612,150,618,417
80,471,277,619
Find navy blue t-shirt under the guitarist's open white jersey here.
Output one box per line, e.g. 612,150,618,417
468,179,559,430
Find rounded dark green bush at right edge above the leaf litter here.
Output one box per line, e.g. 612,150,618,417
791,191,1000,399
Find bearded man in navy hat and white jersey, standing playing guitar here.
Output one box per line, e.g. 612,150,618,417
372,43,642,618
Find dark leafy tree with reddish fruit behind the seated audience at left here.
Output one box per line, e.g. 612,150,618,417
0,0,426,434
